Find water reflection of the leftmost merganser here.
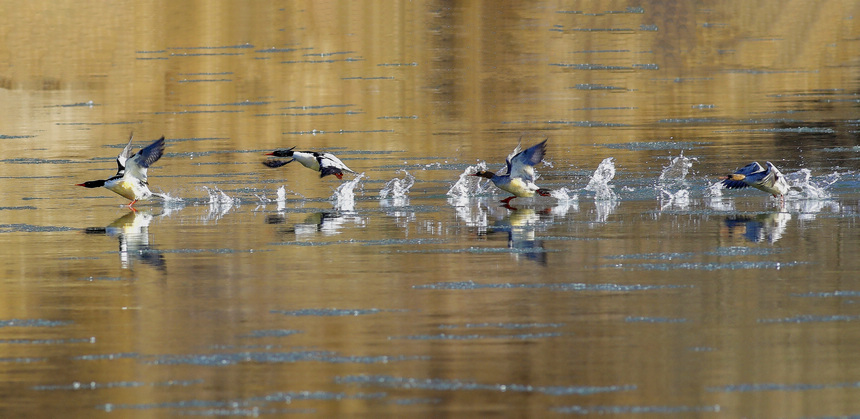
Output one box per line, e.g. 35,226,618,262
85,210,166,271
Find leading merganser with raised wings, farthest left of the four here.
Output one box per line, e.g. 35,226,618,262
75,133,164,209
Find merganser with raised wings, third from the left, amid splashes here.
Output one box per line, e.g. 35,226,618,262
471,140,550,204
